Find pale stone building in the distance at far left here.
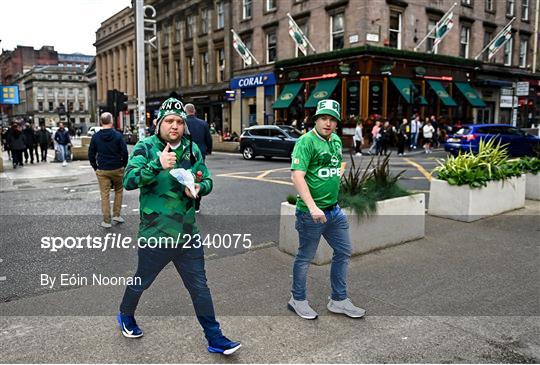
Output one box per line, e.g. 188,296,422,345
12,66,90,131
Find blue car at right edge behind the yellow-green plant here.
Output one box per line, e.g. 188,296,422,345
444,124,540,157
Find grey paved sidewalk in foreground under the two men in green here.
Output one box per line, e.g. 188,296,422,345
0,201,540,363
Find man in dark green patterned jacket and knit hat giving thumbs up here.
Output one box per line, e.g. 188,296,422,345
118,98,241,355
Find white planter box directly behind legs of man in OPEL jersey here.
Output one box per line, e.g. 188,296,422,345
279,194,425,265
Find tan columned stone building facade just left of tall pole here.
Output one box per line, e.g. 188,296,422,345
94,7,137,129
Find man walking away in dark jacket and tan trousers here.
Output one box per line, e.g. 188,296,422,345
88,112,128,228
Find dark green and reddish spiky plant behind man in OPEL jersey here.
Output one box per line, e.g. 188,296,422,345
338,152,410,219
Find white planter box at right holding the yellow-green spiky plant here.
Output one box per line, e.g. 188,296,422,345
428,175,525,222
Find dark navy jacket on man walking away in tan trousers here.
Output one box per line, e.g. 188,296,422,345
88,128,128,170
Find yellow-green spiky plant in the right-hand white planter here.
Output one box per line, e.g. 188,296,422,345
433,138,521,188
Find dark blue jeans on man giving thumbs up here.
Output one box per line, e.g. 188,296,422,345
120,247,222,341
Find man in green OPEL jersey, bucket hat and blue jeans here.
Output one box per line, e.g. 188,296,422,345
288,99,366,319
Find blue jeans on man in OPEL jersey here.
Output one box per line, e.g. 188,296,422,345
292,205,352,300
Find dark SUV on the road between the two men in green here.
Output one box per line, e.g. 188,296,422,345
240,125,302,160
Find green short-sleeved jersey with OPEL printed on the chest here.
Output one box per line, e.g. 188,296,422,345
291,128,343,212
